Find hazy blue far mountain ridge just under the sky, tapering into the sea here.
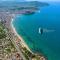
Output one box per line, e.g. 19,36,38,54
0,0,49,7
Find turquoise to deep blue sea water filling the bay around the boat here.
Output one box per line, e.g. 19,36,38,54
13,3,60,60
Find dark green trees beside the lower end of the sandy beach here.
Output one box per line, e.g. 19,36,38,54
23,47,41,60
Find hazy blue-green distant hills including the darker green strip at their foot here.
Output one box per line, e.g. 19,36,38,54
0,1,49,11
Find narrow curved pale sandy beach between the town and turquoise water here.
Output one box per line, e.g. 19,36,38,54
11,18,34,54
